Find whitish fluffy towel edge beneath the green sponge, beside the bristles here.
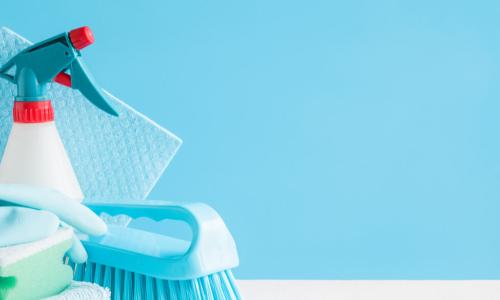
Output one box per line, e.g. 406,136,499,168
44,281,111,300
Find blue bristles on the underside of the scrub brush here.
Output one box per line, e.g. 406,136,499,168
74,262,242,300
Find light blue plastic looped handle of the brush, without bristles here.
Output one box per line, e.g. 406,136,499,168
84,201,239,280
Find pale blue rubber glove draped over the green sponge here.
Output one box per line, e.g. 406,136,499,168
0,184,107,263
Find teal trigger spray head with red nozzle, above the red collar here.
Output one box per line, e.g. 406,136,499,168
0,26,118,116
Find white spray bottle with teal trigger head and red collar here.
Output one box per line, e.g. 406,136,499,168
0,27,118,201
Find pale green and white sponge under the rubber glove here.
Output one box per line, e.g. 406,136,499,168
0,229,73,300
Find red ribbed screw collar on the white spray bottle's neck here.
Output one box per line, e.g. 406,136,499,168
12,100,54,123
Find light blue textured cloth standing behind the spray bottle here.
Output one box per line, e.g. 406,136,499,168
0,27,182,202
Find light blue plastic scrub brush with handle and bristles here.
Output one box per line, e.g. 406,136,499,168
74,201,242,300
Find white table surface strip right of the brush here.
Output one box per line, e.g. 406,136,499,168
238,280,500,300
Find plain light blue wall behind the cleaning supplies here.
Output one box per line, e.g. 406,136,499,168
1,0,500,279
